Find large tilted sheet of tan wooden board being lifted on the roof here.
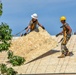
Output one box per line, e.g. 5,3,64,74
9,27,57,62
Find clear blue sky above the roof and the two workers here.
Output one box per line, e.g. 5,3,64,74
0,0,76,35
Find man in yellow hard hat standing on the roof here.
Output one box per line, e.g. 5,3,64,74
56,16,72,58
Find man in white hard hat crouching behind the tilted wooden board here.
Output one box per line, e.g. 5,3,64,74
26,13,45,33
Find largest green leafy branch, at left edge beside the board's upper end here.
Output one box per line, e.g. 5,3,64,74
0,23,12,51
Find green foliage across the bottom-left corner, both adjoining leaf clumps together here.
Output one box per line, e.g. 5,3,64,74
0,64,17,75
